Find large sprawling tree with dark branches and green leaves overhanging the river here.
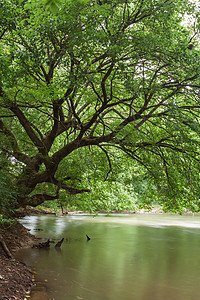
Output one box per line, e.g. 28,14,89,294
0,0,200,210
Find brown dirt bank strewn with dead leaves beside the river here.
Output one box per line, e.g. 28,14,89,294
0,223,38,300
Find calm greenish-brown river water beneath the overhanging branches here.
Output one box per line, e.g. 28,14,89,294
17,215,200,300
